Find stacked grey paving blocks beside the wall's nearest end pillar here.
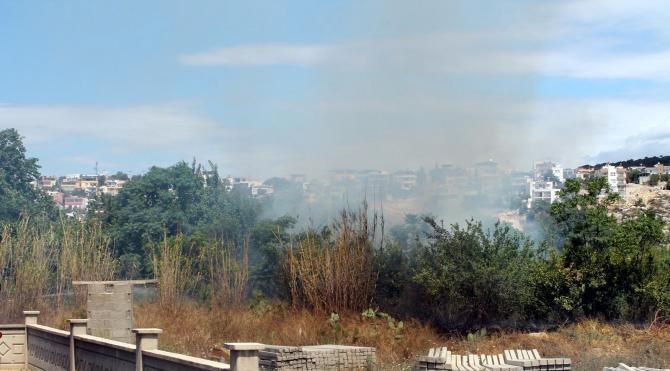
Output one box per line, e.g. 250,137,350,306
259,345,377,371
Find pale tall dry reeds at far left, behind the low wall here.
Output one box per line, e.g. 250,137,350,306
0,219,116,321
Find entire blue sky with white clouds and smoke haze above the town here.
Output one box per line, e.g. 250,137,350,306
0,0,670,178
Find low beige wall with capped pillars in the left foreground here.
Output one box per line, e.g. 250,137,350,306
0,312,252,371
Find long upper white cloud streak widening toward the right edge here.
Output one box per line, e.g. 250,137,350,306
179,0,670,81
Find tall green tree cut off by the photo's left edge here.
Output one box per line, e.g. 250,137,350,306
0,129,55,221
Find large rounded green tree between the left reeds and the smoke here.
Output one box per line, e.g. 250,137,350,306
100,162,260,271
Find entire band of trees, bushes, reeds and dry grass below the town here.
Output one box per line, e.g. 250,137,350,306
0,130,670,370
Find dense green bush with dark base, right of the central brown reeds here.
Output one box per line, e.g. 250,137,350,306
412,219,537,329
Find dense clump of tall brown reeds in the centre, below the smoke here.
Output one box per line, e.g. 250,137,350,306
283,204,376,313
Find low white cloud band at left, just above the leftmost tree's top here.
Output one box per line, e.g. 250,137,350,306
0,104,236,152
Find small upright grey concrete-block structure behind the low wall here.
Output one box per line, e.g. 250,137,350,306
86,282,134,343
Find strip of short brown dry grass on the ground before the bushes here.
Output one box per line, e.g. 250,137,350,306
135,303,670,371
